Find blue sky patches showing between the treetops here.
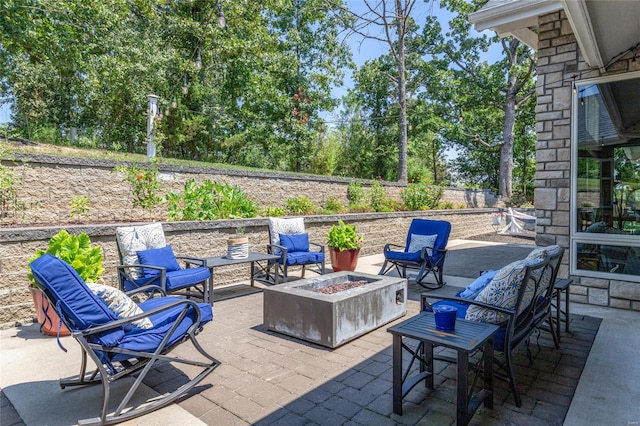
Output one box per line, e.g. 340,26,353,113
0,0,500,124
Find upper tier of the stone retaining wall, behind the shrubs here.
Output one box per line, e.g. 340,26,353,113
0,154,500,226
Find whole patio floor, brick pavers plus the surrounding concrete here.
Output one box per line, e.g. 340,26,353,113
0,240,640,425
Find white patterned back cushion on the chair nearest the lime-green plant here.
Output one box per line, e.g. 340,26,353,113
116,223,167,279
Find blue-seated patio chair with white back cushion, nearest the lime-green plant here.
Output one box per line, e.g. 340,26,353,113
116,223,211,302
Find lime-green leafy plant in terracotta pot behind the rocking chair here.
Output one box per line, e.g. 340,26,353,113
28,229,104,336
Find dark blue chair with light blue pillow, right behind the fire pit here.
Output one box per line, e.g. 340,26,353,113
378,219,451,289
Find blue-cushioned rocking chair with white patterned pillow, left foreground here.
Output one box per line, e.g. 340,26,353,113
31,254,220,424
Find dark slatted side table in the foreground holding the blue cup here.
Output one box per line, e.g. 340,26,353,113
387,312,498,425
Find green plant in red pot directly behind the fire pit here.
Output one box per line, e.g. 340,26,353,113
327,220,362,272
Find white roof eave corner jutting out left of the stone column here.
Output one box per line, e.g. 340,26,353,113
469,0,563,50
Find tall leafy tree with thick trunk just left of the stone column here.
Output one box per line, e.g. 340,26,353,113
425,0,535,199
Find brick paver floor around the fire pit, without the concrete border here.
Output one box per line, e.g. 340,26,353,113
160,286,599,425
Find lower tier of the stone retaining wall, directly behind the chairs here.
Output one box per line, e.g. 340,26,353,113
0,209,496,328
